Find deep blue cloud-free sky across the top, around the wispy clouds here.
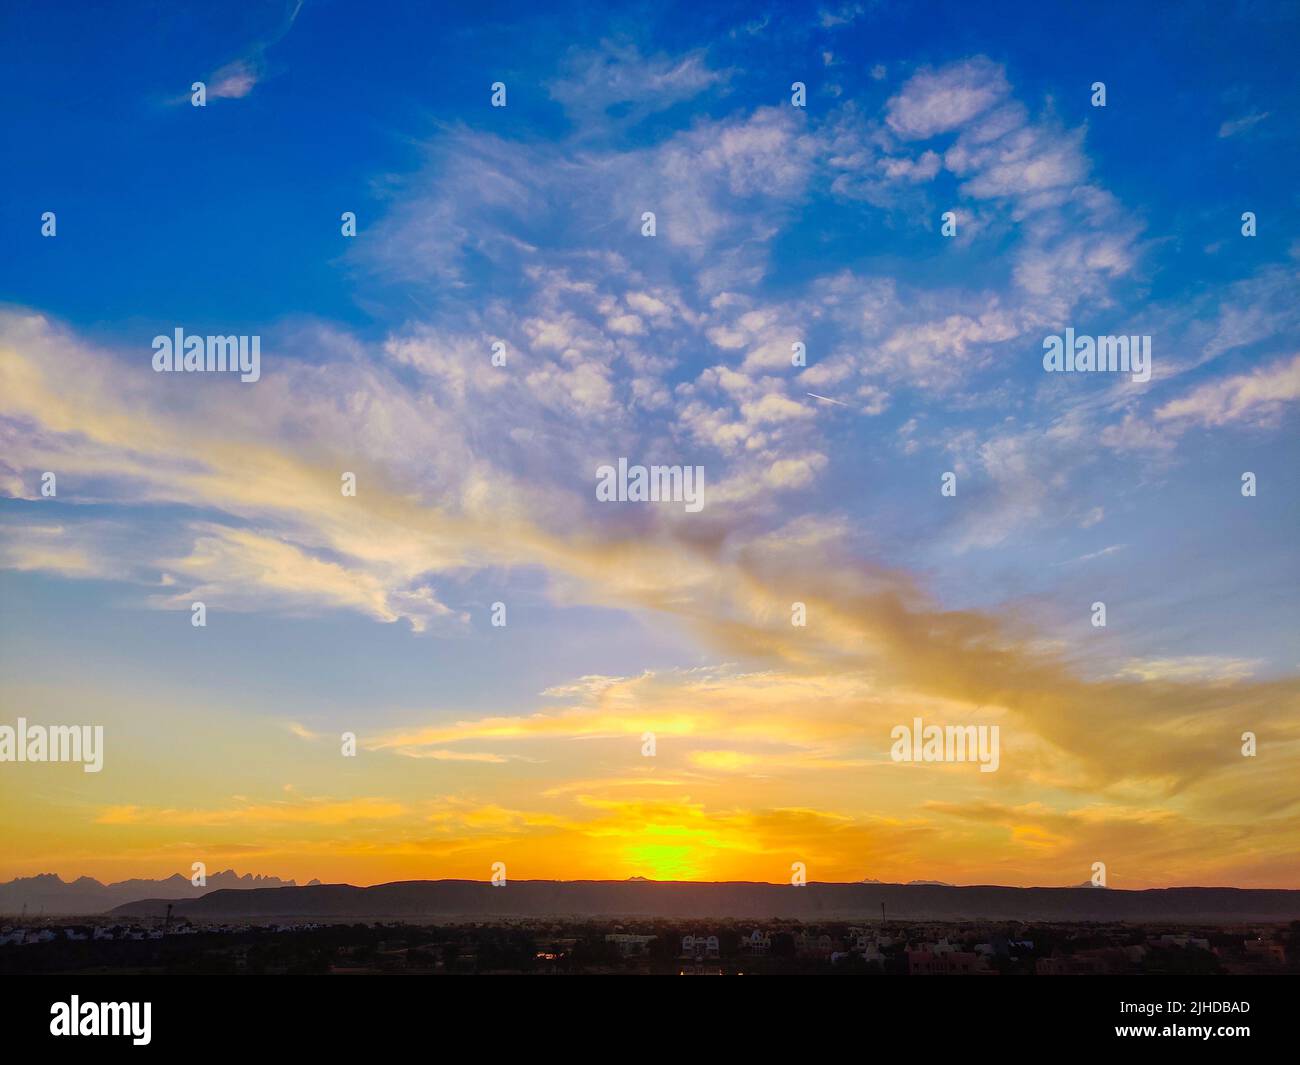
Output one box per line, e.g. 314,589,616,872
0,4,1296,330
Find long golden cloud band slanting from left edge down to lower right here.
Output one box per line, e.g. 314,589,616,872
0,293,1295,832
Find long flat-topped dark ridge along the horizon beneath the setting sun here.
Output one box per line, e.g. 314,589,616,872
114,880,1300,923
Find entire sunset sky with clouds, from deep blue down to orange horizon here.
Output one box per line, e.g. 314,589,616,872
0,0,1300,888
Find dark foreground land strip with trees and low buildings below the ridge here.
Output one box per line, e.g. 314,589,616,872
0,917,1300,977
